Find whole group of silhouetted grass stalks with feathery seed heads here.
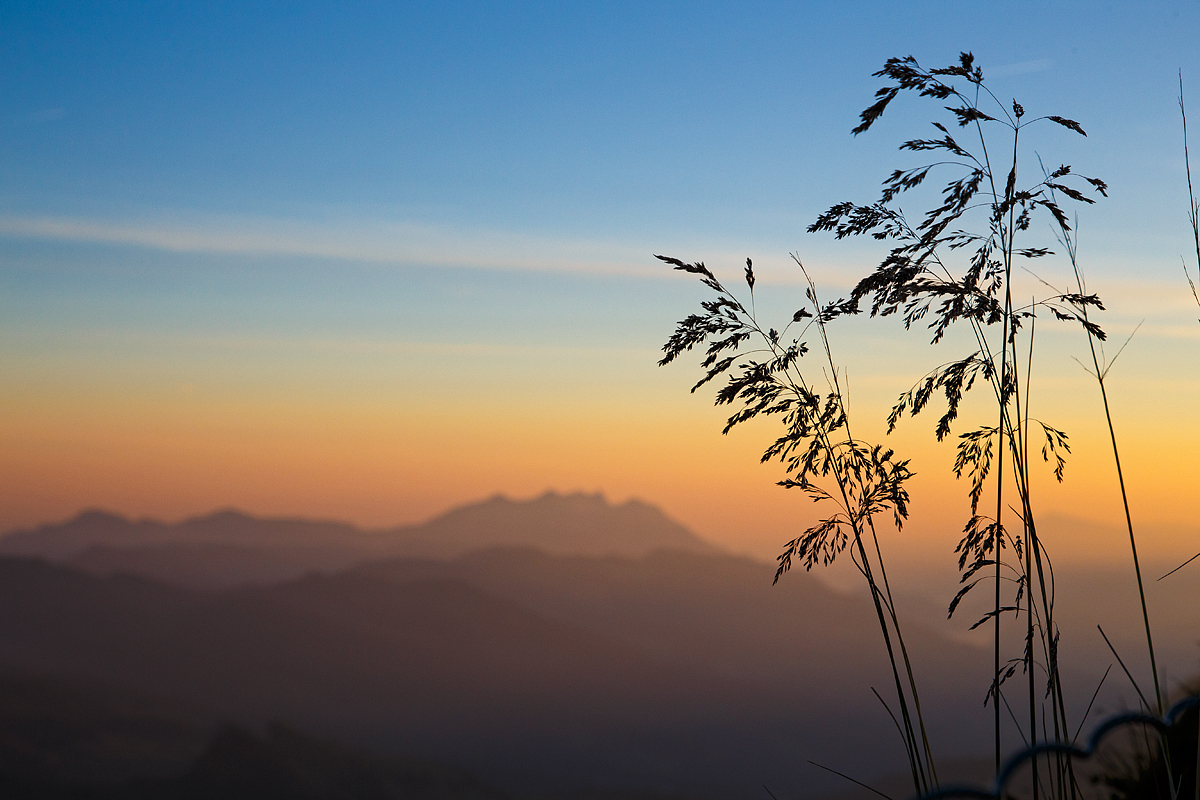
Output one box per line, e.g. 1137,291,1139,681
658,53,1200,799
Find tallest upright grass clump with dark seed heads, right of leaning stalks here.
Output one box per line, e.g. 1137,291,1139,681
809,53,1106,796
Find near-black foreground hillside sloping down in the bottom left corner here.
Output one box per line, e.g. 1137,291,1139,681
0,670,505,800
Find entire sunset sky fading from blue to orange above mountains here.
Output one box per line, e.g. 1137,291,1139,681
0,0,1200,573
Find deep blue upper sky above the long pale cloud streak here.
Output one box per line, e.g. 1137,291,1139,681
0,2,1200,260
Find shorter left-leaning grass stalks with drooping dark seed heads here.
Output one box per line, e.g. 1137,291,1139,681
656,255,937,794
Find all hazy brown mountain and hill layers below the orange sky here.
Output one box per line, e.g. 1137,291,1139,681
0,494,1190,799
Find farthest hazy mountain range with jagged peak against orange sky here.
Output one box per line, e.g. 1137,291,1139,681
0,492,716,588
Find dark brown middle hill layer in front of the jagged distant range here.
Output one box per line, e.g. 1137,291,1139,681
0,555,974,796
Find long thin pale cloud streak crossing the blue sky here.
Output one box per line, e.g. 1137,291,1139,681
0,215,1193,314
